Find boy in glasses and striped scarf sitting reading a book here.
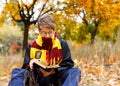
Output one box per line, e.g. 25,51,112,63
9,14,81,86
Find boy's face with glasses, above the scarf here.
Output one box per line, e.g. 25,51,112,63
39,28,55,38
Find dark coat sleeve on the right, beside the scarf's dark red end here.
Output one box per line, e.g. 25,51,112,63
57,39,74,71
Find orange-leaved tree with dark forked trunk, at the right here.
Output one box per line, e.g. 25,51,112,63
63,0,120,44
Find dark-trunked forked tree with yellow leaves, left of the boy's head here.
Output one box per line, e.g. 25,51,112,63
0,0,52,51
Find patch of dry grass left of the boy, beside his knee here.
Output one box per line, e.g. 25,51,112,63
0,53,23,82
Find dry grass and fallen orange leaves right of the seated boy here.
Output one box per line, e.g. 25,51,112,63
69,41,120,86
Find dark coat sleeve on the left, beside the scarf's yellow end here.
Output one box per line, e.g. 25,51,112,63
22,45,30,68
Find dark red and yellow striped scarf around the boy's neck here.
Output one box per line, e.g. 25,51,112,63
30,35,62,66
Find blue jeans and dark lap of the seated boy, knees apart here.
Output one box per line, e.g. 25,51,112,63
8,68,81,86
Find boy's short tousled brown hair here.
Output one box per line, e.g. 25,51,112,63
37,14,55,30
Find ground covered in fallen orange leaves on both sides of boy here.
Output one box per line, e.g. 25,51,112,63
0,55,120,86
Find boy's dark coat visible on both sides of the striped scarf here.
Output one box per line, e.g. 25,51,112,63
22,39,74,72
